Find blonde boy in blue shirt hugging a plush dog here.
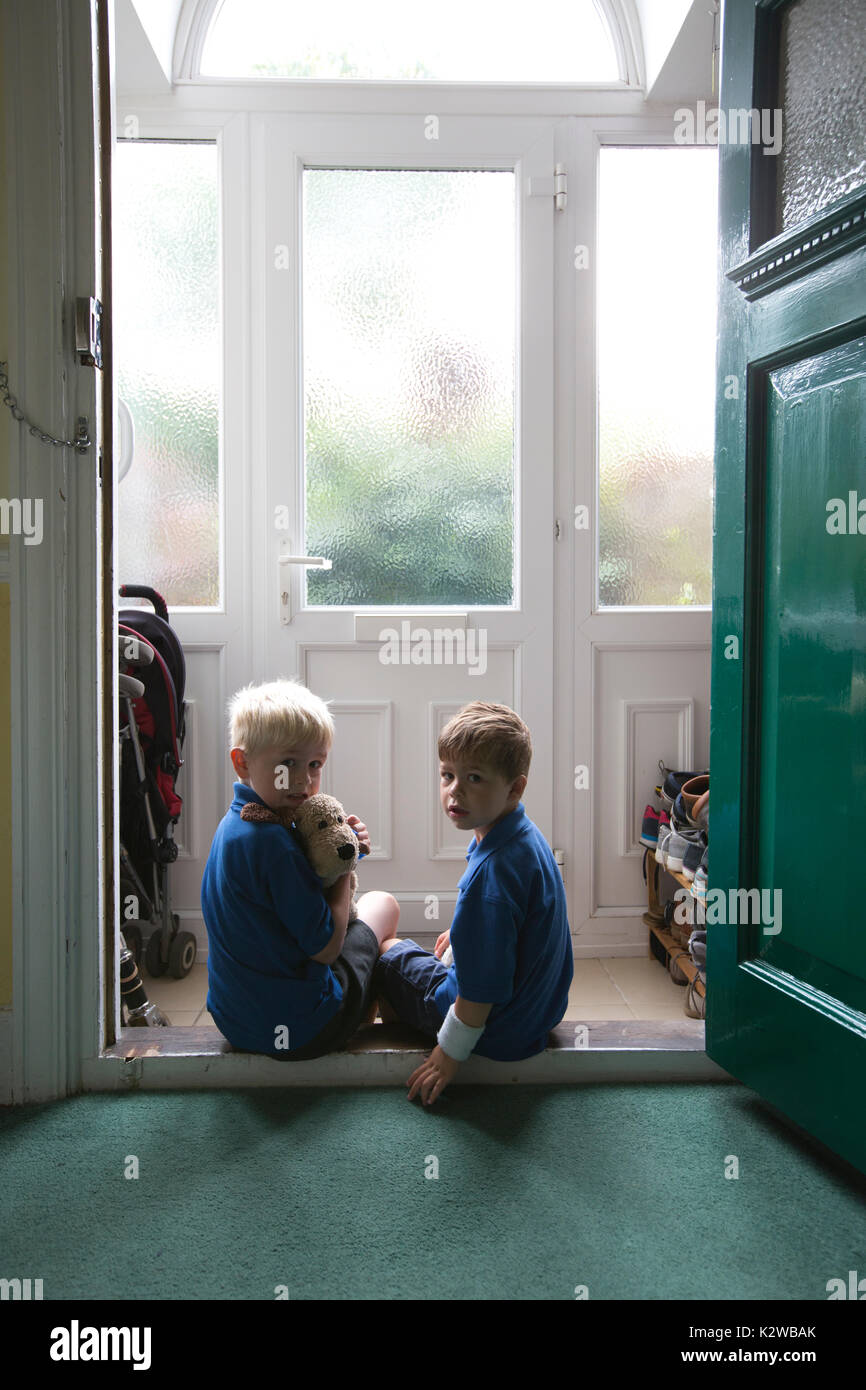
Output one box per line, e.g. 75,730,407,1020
202,681,400,1061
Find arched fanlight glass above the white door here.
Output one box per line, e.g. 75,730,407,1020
202,0,620,83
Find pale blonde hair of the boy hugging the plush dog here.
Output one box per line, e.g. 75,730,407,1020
228,681,334,758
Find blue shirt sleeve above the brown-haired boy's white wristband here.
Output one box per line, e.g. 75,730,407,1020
450,876,518,1004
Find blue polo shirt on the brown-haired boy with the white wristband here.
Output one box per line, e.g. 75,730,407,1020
434,802,574,1062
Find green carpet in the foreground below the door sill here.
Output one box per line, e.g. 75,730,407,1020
0,1084,866,1301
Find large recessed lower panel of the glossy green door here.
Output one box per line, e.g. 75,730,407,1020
753,338,866,989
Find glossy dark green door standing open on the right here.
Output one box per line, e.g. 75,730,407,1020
706,0,866,1172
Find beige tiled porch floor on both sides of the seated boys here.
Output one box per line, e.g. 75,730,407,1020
142,956,700,1027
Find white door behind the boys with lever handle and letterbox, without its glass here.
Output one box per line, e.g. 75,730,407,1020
241,114,557,937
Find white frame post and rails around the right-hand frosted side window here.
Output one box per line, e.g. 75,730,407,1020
553,116,712,959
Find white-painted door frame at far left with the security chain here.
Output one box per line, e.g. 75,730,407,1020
0,0,107,1104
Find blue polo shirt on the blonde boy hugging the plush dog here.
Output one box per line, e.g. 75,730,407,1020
202,781,343,1056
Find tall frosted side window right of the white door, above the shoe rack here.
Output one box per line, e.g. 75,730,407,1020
600,146,717,607
